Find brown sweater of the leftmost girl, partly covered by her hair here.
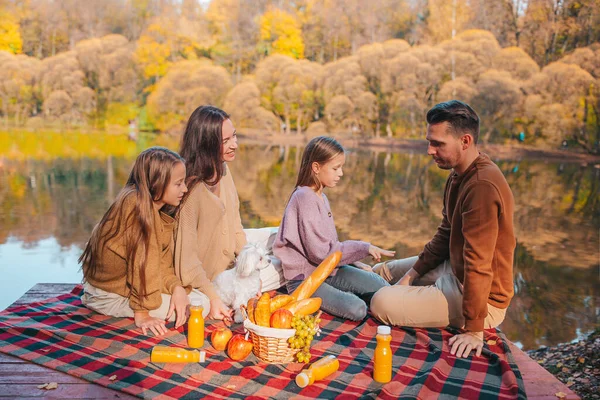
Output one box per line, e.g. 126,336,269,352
84,193,184,311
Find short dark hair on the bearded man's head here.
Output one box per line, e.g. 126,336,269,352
427,100,479,143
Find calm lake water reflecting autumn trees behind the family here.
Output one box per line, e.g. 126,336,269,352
0,132,600,349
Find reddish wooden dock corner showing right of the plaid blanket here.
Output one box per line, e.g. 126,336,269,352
508,342,579,400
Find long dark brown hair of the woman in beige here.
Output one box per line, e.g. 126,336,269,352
179,106,229,195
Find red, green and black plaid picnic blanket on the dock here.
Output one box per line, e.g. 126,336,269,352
0,286,526,399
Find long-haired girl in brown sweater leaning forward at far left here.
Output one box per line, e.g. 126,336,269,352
79,147,208,335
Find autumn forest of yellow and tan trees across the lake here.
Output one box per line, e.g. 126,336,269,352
0,0,600,153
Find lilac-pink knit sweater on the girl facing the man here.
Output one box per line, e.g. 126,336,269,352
273,186,370,280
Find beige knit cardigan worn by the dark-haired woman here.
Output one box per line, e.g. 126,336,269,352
175,167,246,300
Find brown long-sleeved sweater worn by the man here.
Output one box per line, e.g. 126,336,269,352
413,153,516,332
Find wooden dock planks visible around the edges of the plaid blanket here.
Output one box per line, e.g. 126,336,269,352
0,283,579,400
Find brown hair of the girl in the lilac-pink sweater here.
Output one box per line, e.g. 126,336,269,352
294,136,344,190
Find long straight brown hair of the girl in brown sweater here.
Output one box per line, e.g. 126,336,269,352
79,147,185,296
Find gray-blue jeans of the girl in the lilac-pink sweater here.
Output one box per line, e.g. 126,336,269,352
286,265,389,321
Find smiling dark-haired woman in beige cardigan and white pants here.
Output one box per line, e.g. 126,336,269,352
175,106,283,319
